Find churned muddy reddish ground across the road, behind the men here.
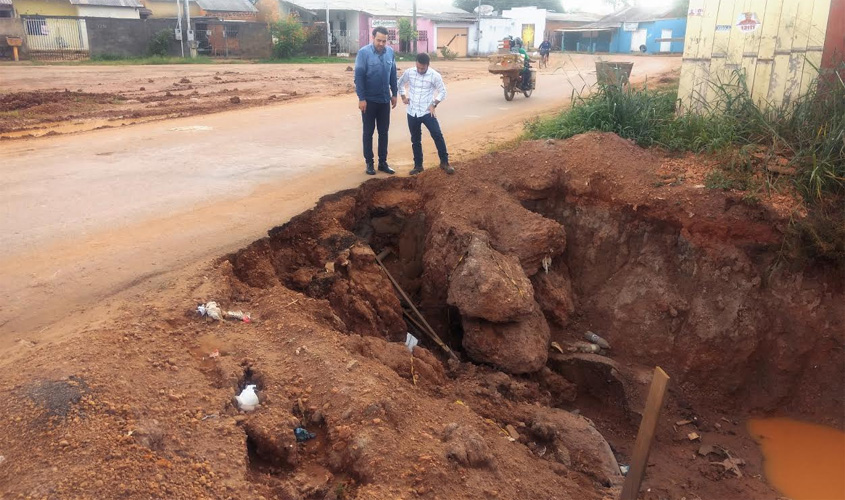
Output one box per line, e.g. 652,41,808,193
0,61,485,139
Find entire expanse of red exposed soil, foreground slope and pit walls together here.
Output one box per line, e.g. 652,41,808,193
0,133,845,500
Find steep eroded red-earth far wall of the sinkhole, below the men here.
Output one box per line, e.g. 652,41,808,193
223,134,845,496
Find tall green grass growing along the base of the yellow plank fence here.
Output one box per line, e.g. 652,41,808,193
525,66,845,201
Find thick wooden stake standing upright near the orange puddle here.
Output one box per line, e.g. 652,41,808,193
621,366,669,500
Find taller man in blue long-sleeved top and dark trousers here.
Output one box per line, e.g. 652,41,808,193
355,26,398,175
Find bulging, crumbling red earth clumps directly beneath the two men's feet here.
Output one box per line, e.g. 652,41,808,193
230,146,566,373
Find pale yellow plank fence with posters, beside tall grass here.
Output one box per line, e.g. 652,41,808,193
678,0,845,111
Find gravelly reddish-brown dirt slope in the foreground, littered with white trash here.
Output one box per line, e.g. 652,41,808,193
0,282,613,499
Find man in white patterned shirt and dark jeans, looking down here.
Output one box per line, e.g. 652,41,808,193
399,53,455,175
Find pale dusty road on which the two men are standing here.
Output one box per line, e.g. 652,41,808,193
0,56,680,360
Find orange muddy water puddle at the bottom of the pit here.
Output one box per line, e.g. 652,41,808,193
748,418,845,500
